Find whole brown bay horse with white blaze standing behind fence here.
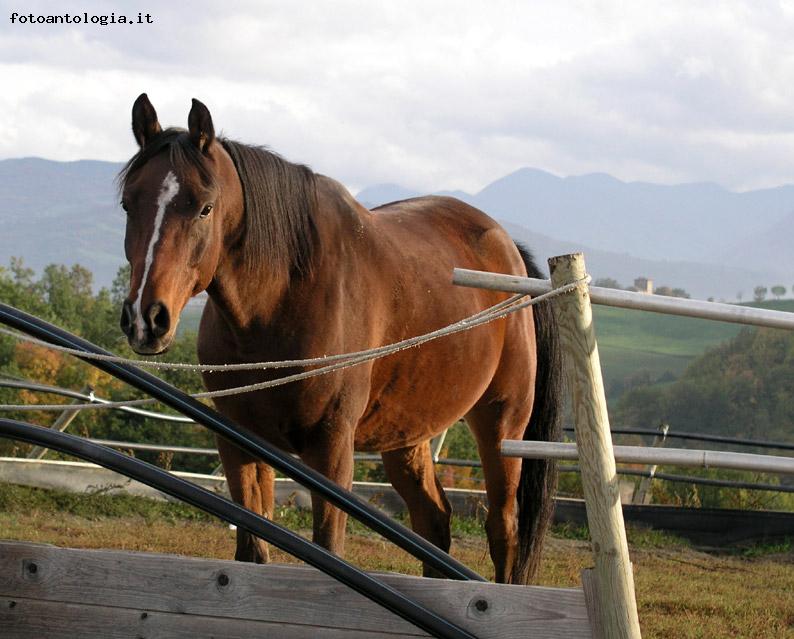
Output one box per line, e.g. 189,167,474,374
120,94,560,583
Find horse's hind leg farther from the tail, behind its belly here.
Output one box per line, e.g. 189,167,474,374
381,441,452,577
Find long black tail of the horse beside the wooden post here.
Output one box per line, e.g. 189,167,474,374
510,243,563,584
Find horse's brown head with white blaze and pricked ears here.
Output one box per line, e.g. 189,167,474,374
120,93,243,355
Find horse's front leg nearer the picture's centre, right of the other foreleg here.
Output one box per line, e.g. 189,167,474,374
301,428,353,556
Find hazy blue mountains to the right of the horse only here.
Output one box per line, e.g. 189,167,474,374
357,168,794,300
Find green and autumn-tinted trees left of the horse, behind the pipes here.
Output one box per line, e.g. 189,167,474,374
0,259,217,472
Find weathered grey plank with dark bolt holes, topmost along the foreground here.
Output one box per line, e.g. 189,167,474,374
0,542,590,639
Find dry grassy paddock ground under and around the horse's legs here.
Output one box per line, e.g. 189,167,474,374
0,484,794,639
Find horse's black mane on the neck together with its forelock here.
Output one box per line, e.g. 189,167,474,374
117,128,316,275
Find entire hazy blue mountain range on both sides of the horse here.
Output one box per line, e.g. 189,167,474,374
0,158,794,300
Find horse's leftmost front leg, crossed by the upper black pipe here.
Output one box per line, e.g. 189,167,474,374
218,438,275,564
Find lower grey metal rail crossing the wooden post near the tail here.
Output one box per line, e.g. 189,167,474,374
502,439,794,474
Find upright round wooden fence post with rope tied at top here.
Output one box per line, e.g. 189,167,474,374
549,253,641,639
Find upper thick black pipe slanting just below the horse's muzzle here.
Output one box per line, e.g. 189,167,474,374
0,303,487,581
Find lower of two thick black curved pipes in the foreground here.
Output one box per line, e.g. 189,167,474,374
0,418,475,639
